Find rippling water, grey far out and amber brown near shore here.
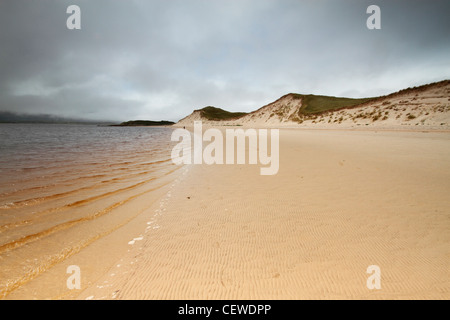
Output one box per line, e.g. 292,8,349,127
0,124,179,298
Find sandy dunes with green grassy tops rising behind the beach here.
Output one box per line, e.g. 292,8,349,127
176,80,450,129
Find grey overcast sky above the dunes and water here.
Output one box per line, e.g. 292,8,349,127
0,0,450,121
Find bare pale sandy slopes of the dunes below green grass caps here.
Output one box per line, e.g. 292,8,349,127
176,80,450,130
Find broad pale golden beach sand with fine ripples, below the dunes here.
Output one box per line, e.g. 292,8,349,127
72,130,450,299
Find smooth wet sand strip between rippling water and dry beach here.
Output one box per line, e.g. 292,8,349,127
0,167,183,300
